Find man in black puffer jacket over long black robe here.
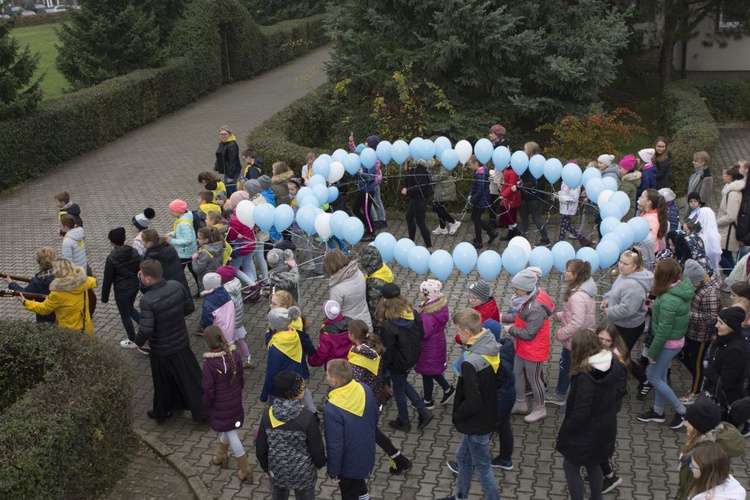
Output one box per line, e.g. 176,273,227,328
135,259,206,422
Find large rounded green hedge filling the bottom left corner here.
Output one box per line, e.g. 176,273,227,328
0,321,135,499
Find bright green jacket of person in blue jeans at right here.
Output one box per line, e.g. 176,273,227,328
648,277,695,359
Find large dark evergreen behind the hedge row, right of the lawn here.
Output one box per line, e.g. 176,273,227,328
57,0,164,88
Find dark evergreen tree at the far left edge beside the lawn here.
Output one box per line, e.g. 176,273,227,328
0,21,43,120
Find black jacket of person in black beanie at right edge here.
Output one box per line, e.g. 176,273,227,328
703,332,748,408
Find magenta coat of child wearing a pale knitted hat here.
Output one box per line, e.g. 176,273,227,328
414,297,450,375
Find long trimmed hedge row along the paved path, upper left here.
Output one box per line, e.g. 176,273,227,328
0,10,325,192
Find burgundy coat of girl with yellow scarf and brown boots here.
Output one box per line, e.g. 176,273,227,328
203,346,245,432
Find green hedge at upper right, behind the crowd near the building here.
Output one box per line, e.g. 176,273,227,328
664,82,719,196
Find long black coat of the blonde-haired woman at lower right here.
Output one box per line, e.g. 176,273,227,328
555,360,625,466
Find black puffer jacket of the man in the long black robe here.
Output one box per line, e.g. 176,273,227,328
135,279,195,357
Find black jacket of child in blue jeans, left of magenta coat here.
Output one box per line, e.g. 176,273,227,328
380,309,424,374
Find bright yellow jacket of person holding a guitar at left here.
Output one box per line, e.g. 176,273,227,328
23,267,96,335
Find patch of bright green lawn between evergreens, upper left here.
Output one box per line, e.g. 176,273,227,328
11,23,70,101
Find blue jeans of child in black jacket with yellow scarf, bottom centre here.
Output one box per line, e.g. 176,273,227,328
456,432,500,500
